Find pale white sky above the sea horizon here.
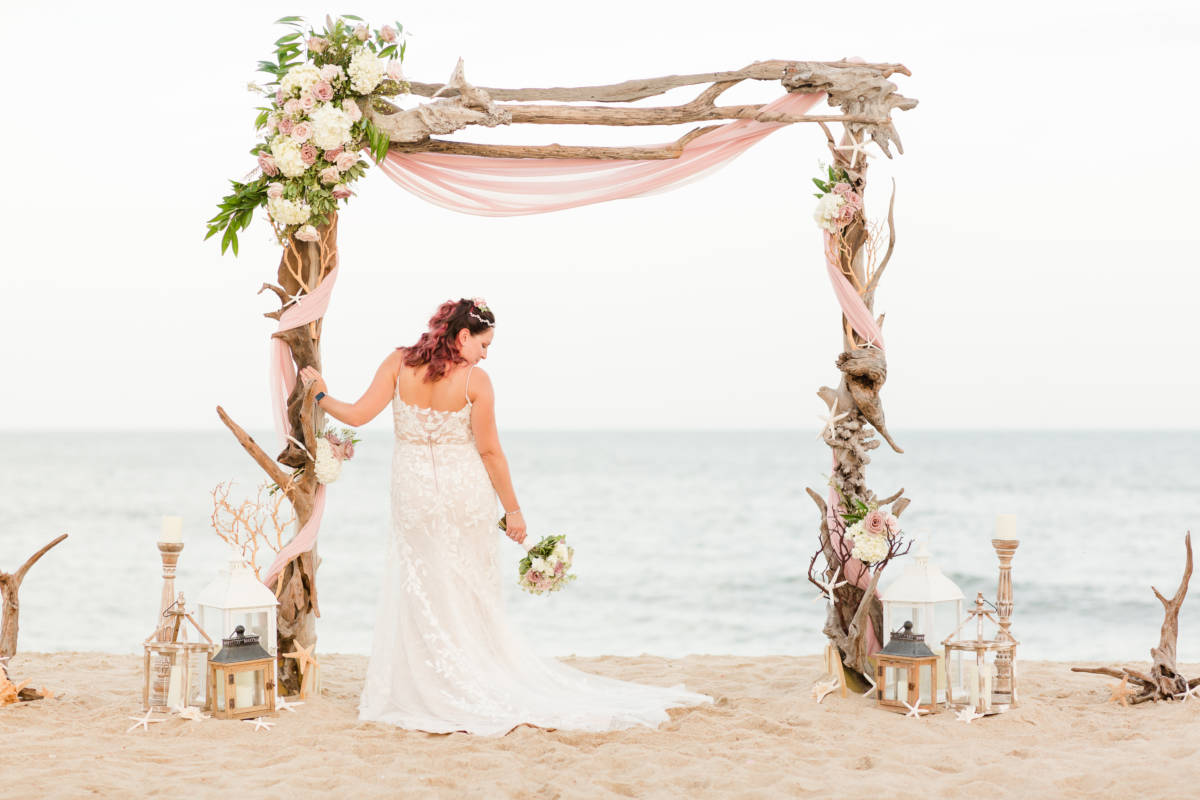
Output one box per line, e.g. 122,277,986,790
0,0,1200,435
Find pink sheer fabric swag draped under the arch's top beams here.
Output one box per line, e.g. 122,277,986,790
380,94,824,217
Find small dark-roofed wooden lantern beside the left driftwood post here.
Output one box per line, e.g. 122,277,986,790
209,625,275,720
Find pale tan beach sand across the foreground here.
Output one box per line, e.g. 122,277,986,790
0,652,1200,800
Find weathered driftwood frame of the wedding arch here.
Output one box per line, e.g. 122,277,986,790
217,17,917,693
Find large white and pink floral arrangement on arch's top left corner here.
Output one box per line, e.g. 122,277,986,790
205,14,409,255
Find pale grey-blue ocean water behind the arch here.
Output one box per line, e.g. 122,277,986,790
0,429,1200,661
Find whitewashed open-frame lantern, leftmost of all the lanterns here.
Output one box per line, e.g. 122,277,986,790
142,593,217,712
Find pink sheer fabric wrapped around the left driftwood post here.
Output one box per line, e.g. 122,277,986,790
263,266,337,589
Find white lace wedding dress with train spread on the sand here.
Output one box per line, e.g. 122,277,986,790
359,377,713,735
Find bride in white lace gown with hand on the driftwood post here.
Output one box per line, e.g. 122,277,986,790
301,299,713,735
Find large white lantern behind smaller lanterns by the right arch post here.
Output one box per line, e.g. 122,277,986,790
881,542,966,702
